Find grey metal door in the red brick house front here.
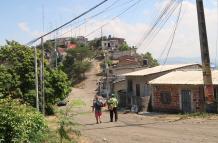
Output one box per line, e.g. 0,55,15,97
181,90,192,113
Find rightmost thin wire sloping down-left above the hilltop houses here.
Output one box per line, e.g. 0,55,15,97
85,0,141,37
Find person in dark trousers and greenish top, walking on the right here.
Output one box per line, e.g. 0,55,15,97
108,94,118,122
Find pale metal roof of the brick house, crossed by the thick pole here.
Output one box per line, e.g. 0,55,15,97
149,70,218,85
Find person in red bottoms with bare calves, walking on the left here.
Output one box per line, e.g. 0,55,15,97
92,96,103,124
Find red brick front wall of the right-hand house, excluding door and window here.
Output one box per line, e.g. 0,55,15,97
152,85,204,112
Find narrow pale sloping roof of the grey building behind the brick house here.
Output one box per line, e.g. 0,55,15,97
122,64,199,76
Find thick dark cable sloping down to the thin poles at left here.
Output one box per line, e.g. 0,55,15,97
27,0,108,45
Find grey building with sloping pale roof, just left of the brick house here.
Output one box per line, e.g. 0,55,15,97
123,64,201,111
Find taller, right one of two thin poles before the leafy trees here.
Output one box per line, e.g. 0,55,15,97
40,37,45,115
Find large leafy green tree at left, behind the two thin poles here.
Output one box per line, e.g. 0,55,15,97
0,41,70,110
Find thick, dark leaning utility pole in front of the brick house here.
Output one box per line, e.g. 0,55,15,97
196,0,215,110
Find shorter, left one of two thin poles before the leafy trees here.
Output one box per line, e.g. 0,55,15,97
34,46,39,111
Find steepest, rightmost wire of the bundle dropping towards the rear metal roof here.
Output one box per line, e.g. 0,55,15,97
163,0,183,65
